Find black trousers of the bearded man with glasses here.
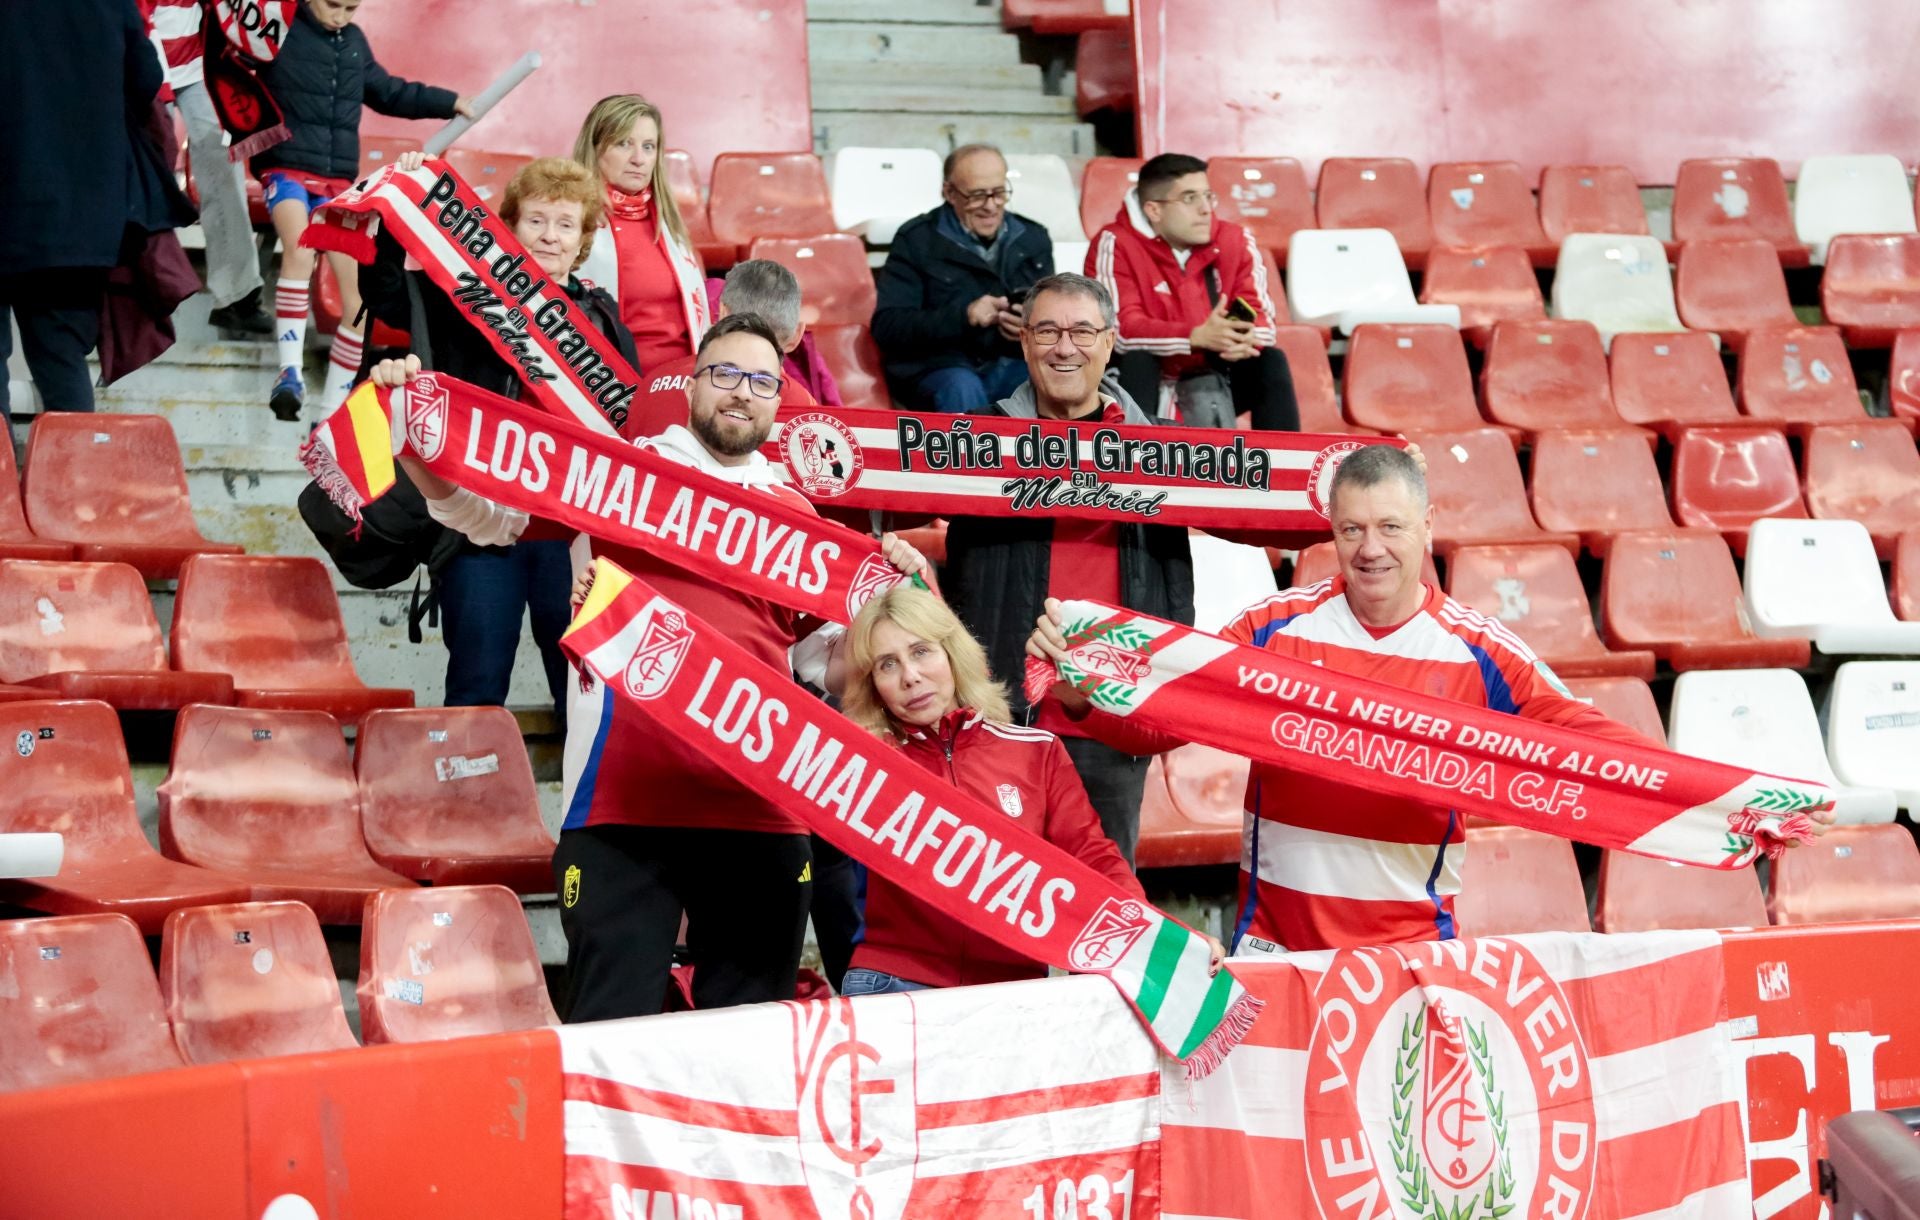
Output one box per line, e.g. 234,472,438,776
553,826,814,1022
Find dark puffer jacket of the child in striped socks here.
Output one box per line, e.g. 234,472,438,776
252,4,459,181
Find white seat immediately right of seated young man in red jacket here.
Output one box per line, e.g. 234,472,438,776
1286,229,1459,334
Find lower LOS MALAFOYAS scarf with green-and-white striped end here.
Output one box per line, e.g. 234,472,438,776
561,559,1260,1080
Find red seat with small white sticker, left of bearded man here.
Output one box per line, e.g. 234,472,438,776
353,707,553,893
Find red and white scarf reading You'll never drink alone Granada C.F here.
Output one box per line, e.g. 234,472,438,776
1025,601,1834,868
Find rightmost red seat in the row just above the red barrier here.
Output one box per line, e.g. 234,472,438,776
1766,826,1920,926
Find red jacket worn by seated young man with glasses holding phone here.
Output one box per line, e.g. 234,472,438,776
1087,190,1275,375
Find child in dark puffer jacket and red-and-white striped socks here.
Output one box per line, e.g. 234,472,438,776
252,0,472,421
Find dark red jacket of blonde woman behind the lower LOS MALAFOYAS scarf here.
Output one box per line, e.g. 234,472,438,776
852,709,1146,988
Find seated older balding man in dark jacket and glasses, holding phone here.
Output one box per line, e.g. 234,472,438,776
874,144,1054,411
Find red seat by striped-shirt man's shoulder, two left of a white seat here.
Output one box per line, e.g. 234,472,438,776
1446,544,1653,680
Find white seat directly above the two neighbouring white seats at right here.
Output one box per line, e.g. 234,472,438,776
1745,521,1920,657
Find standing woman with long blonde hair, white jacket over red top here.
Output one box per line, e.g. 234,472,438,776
574,94,712,373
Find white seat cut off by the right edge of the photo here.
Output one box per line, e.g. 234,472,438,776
1826,661,1920,815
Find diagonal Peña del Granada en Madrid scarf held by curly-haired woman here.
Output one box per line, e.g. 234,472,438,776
300,158,639,434
